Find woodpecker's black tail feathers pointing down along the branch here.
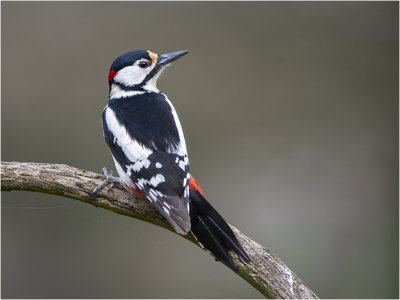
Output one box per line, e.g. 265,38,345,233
190,190,250,271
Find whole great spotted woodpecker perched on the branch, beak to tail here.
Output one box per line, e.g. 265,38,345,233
96,50,249,271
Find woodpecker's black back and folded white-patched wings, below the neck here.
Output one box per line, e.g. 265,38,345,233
103,96,190,234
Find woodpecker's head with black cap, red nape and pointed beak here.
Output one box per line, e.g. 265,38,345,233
108,50,189,91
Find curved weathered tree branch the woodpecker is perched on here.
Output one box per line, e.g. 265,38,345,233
1,162,318,299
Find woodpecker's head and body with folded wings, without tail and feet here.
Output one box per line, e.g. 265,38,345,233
103,51,190,234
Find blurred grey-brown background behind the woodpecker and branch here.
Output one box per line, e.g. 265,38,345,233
1,2,399,298
